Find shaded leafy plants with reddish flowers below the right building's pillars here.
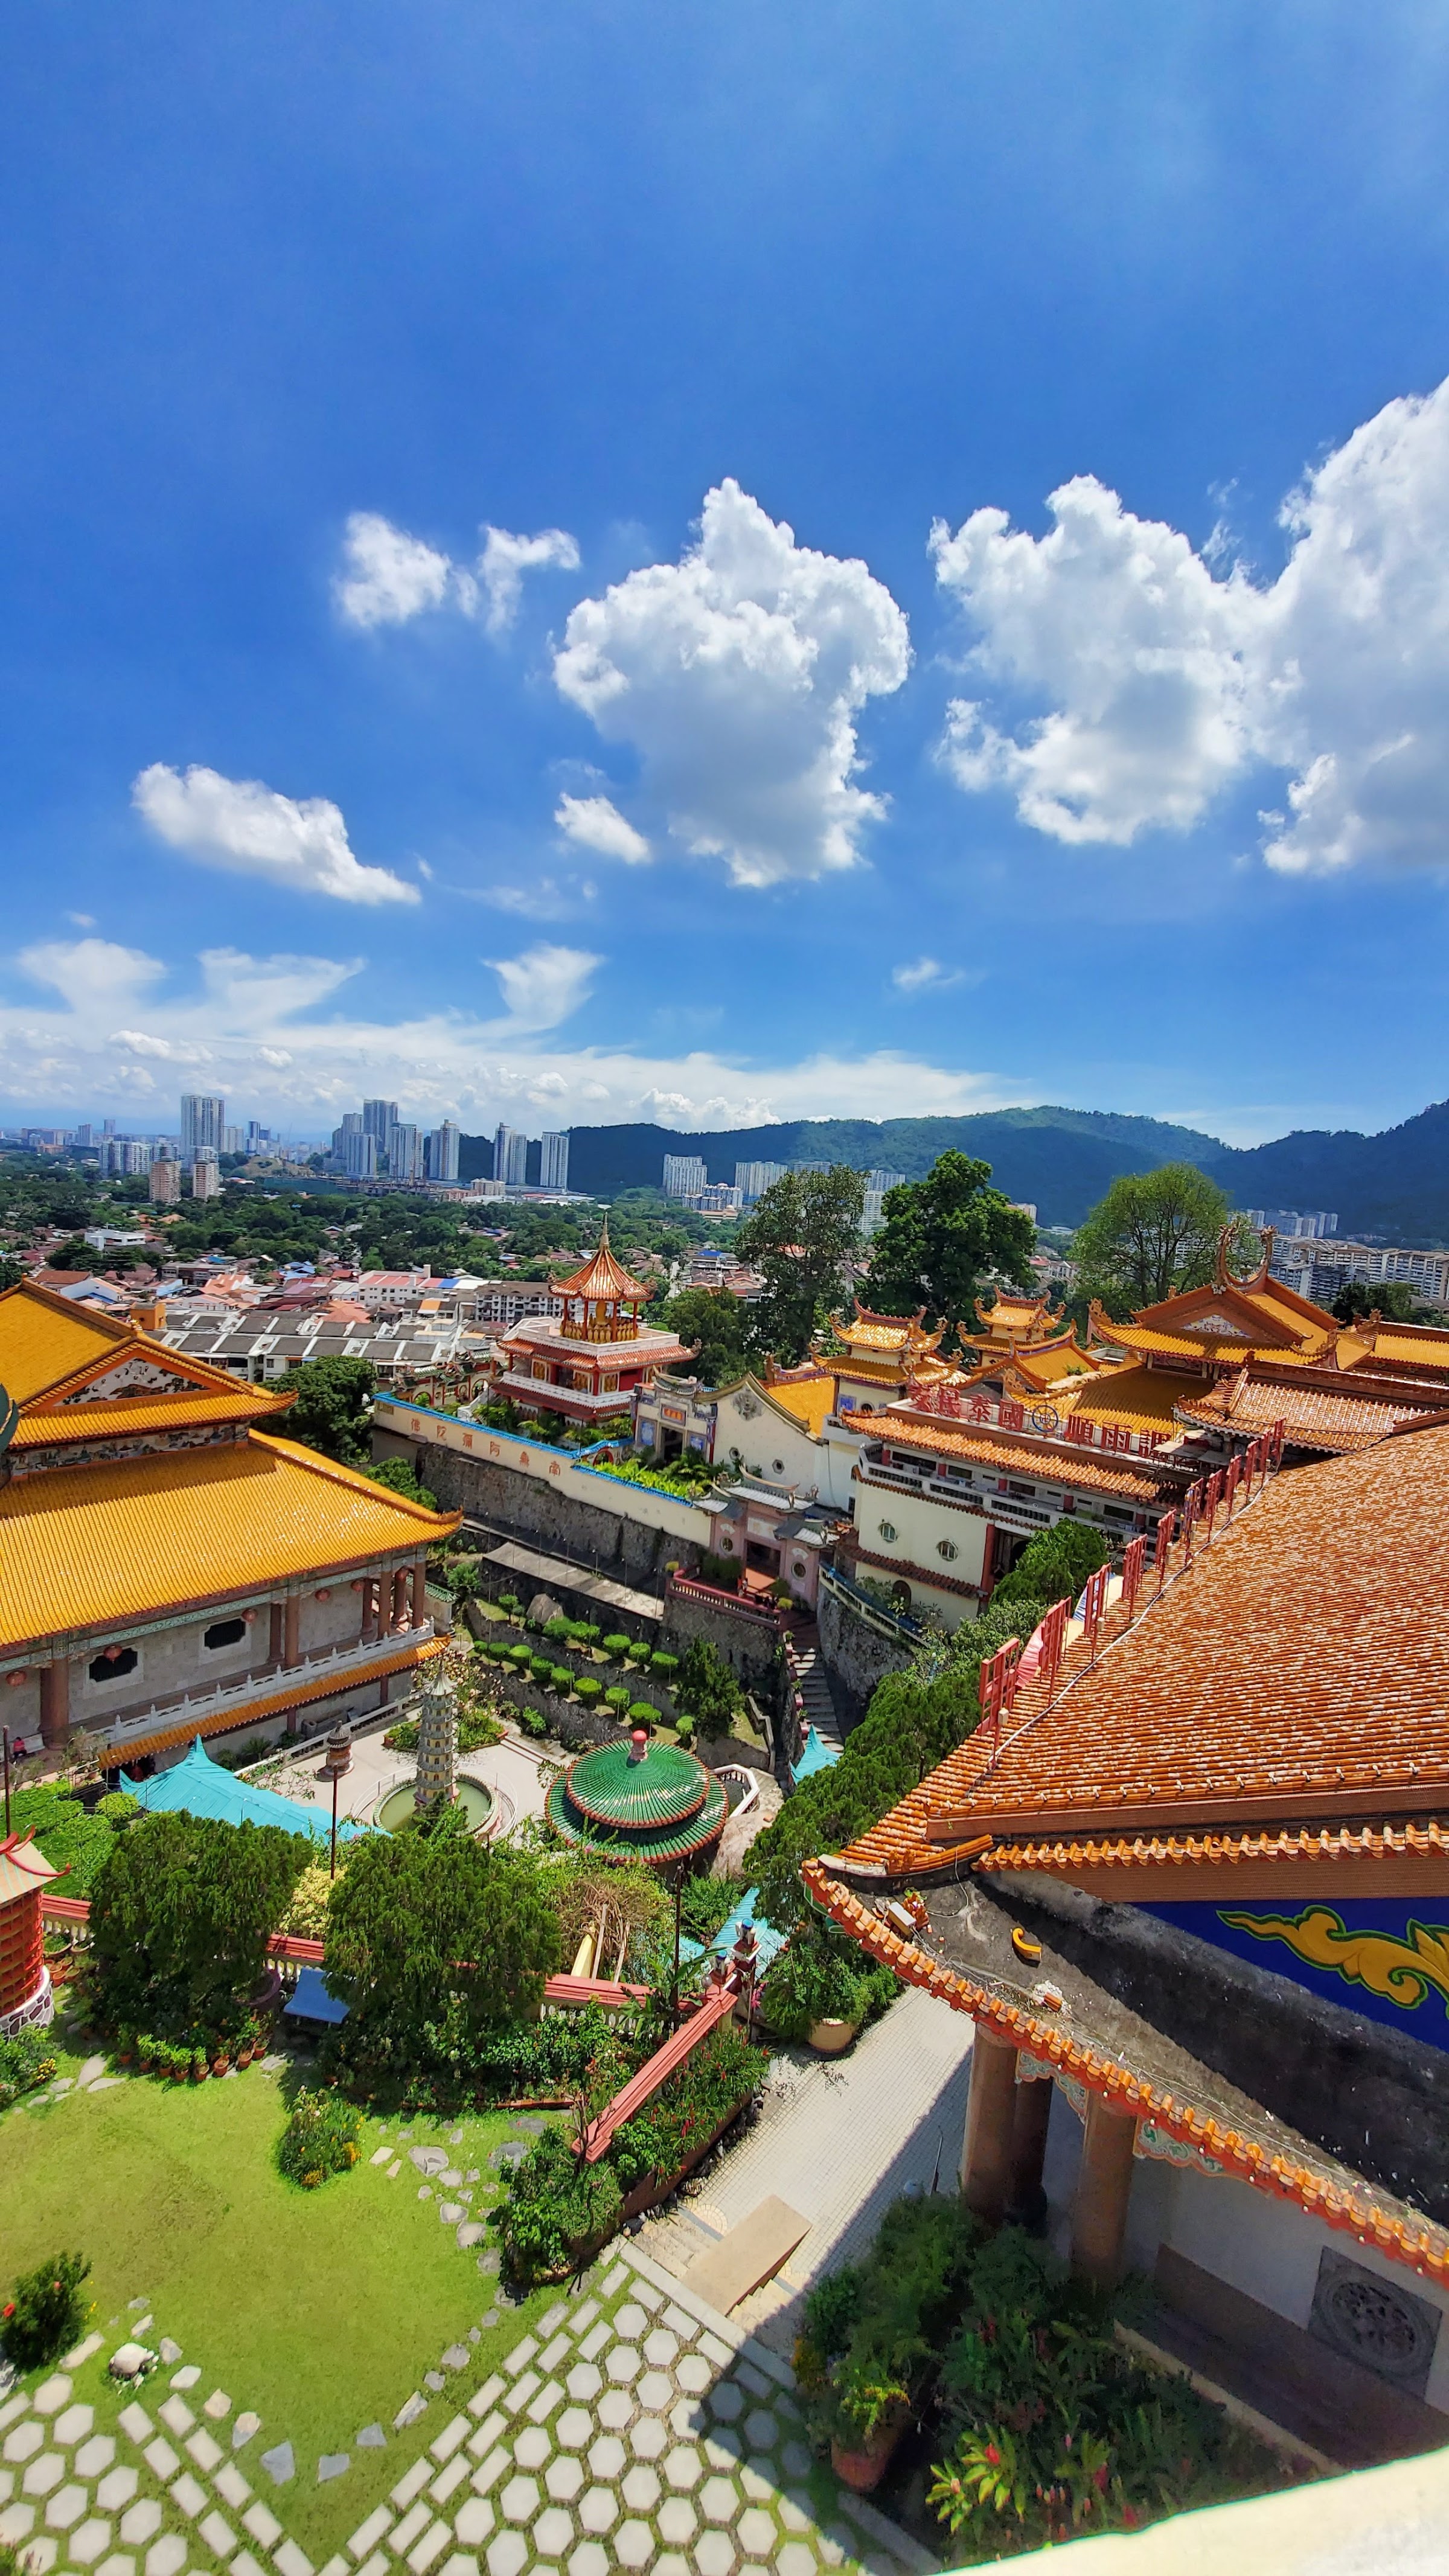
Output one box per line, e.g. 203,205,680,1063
928,2228,1287,2558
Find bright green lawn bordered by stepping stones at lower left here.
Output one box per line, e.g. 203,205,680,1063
0,2048,557,2560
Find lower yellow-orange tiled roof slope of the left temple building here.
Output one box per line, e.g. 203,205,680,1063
0,1432,461,1651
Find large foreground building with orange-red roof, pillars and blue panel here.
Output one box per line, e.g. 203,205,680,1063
804,1422,1449,2460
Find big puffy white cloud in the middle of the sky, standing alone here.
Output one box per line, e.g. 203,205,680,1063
554,479,910,886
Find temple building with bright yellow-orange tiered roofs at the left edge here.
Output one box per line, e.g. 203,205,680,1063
0,1283,456,1772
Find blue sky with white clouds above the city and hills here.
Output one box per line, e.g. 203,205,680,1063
0,0,1449,1141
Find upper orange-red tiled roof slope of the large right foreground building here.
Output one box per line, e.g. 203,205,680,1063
843,1425,1449,1875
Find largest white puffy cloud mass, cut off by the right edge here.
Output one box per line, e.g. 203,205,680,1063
931,384,1449,874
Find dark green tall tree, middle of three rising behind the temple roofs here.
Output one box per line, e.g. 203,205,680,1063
871,1151,1037,1340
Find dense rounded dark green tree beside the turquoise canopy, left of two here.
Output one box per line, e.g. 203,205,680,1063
90,1808,315,2033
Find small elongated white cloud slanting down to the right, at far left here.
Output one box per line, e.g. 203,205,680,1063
132,760,420,904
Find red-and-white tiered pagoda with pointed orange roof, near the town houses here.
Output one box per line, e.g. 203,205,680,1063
493,1218,699,1425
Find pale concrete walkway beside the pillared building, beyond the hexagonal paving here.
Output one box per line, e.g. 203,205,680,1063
639,1989,972,2352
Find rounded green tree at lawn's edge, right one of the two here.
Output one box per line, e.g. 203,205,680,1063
322,1834,560,2056
